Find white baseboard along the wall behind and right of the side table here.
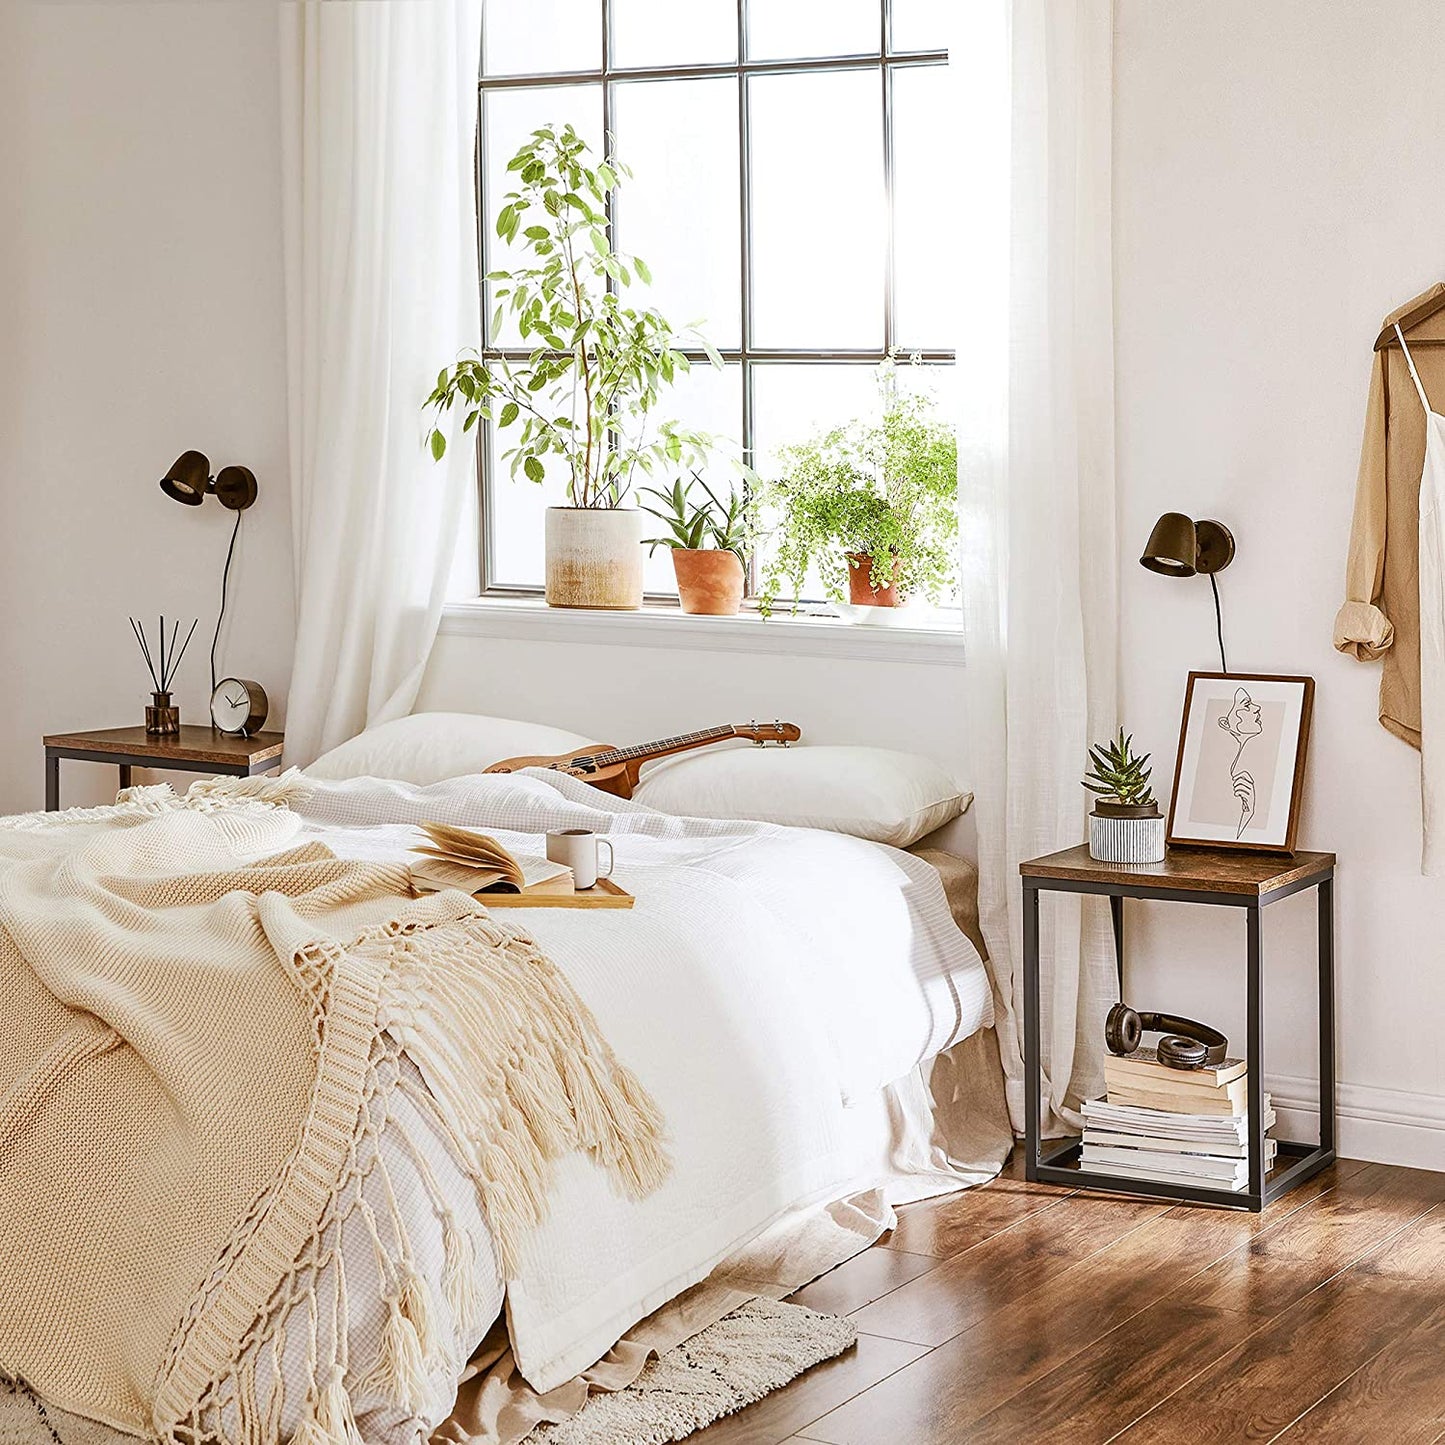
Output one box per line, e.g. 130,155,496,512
1264,1075,1445,1170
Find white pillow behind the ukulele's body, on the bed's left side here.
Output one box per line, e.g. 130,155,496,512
306,712,595,783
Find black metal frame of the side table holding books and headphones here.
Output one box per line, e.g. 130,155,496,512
1023,867,1335,1214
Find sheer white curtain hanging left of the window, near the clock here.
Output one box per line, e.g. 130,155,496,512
280,0,481,763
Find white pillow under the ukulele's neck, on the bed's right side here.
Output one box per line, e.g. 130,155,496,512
633,747,974,848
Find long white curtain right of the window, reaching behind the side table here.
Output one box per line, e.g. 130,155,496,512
952,0,1118,1133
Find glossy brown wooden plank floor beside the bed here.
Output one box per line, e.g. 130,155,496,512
692,1160,1445,1445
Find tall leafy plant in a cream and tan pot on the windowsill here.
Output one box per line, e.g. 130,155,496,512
425,126,723,608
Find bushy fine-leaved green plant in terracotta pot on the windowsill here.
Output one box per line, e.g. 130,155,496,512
753,367,958,616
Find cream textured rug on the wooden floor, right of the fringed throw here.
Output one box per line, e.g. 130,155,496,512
526,1299,858,1445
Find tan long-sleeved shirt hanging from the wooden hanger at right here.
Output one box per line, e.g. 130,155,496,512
1335,282,1445,747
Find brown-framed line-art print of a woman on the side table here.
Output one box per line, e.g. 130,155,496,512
1169,672,1315,853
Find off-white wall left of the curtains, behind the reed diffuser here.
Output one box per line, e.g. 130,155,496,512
0,0,292,812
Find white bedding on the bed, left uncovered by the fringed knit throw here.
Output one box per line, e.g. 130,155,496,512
0,751,1009,1445
